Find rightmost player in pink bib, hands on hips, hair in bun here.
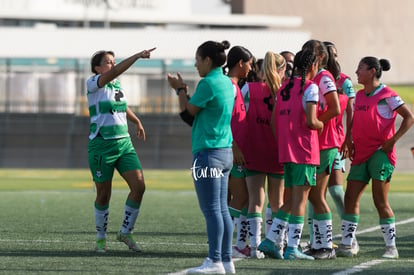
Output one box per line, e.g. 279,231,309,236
337,56,414,259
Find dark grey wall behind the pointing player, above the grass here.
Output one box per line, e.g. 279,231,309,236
0,113,192,169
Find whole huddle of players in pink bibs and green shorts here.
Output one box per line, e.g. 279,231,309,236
227,40,414,260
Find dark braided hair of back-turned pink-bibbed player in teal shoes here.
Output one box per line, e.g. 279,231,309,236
280,49,316,100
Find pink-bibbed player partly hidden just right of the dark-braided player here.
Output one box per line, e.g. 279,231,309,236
302,40,341,259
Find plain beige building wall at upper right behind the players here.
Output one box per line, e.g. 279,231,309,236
231,0,414,84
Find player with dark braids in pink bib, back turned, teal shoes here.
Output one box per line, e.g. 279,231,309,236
259,50,323,260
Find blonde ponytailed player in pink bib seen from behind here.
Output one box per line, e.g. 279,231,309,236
244,52,286,259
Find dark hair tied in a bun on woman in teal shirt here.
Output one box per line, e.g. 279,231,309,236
197,40,230,68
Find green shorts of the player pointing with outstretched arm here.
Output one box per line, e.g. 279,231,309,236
88,137,142,182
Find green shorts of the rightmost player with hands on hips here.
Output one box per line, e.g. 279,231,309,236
347,150,394,184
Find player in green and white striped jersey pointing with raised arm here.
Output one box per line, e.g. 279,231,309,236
86,48,155,252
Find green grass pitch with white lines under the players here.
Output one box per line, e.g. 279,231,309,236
0,169,414,274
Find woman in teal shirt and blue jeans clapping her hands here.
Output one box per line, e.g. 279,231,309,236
168,41,236,274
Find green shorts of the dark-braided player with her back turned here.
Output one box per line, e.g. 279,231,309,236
284,162,316,188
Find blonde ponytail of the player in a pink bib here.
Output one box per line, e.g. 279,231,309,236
263,51,286,98
